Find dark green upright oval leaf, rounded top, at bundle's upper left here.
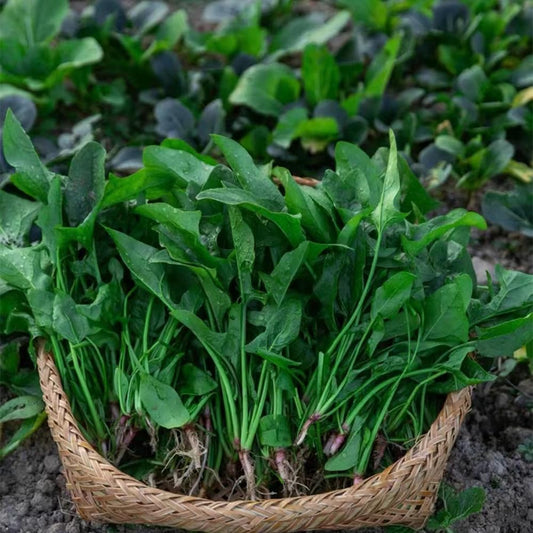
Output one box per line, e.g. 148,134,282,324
65,142,106,226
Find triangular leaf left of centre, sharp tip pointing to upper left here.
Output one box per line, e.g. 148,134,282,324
106,228,171,305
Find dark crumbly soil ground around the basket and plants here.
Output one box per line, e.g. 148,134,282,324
0,0,533,533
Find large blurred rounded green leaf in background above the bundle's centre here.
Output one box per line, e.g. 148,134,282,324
229,63,300,117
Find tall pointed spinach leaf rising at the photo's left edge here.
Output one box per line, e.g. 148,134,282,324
2,109,54,203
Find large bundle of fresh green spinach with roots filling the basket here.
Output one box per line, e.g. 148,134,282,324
0,113,533,498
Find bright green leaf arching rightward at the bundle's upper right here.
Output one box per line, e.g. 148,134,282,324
402,209,487,255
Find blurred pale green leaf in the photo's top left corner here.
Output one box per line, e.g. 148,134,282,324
0,0,68,48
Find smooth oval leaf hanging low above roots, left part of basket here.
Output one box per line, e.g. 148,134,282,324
139,374,191,429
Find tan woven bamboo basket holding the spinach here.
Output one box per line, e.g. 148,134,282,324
37,347,471,533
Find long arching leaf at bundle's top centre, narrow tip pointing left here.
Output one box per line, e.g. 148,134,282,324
197,188,304,246
